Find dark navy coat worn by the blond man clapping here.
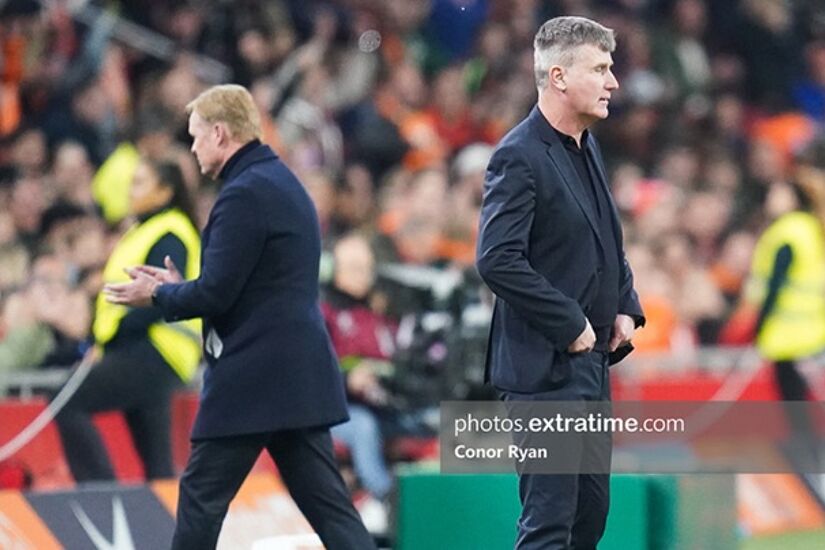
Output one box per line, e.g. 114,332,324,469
155,145,347,439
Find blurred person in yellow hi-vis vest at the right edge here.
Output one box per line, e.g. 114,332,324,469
745,137,825,471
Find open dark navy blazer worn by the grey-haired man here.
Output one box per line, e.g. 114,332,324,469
476,107,644,393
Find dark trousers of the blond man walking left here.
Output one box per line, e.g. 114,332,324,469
172,428,375,550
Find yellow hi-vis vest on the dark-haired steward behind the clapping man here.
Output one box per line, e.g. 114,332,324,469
92,209,201,382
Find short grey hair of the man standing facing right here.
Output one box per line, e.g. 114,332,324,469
533,16,616,90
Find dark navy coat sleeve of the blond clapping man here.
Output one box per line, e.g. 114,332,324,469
155,185,266,321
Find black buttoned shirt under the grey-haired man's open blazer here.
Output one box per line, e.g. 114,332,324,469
554,128,620,351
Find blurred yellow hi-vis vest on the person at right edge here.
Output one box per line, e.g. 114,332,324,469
746,212,825,361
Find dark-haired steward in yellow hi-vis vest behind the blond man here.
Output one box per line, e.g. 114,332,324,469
57,159,201,482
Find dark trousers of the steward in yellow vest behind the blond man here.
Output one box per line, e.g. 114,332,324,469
56,340,182,482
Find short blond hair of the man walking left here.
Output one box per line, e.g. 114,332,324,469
186,84,261,143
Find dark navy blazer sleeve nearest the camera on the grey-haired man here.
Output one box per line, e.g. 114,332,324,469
476,142,586,350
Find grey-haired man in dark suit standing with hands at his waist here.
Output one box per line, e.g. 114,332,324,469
477,17,644,550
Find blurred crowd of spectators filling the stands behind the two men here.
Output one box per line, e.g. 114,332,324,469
0,0,825,384
